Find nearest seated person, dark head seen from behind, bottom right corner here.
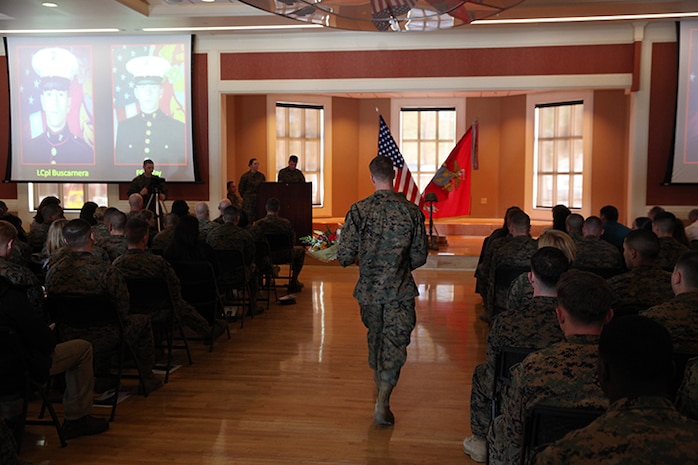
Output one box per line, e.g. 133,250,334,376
534,316,698,465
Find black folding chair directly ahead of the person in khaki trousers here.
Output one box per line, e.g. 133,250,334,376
46,294,144,421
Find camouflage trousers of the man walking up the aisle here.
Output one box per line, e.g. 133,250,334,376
361,299,416,385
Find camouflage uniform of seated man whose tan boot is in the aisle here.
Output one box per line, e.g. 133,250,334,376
470,296,565,438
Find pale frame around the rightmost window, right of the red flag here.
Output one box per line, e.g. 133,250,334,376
512,90,594,221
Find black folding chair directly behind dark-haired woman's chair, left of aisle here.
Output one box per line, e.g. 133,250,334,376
126,278,192,383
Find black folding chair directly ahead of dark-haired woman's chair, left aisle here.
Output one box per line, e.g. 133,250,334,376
216,249,257,328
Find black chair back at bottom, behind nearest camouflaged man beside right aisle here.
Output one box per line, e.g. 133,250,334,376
521,405,605,465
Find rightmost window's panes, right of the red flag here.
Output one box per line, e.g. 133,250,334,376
533,101,584,209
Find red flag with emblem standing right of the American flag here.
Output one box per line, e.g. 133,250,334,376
422,121,478,218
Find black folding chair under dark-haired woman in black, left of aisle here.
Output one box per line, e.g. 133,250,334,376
170,261,230,352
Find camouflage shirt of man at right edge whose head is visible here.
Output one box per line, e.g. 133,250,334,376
640,292,698,355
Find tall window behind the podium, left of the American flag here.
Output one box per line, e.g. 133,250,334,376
274,102,324,206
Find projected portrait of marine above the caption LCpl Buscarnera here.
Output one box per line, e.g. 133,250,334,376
18,46,95,165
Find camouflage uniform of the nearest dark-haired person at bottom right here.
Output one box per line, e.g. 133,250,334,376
534,396,698,465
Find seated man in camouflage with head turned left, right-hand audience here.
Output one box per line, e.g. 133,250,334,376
608,229,674,313
